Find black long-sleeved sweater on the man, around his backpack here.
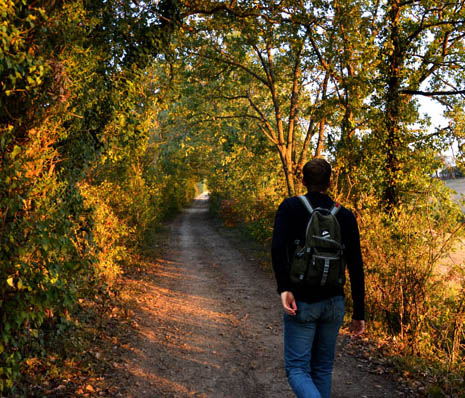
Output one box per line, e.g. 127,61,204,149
271,192,365,320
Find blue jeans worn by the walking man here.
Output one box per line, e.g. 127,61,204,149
284,296,345,398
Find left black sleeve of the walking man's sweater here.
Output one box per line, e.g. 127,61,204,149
271,200,291,293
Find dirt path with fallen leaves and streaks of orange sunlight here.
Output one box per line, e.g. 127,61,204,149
111,197,406,398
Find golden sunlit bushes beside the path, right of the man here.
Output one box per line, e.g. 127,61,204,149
342,181,465,396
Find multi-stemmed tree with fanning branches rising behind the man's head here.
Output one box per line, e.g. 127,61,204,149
176,1,358,195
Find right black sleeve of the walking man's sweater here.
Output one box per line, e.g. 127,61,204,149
346,213,365,320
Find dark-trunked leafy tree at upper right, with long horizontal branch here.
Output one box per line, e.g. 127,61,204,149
377,0,465,208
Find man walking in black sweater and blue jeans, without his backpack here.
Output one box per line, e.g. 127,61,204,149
272,158,365,398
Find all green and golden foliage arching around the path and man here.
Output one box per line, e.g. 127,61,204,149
0,0,465,394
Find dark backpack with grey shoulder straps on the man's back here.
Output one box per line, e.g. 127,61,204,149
290,195,345,288
